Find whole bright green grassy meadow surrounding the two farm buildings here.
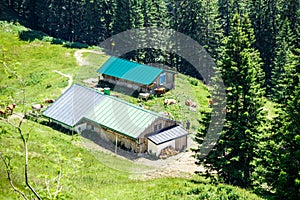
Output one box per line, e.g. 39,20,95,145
0,22,260,200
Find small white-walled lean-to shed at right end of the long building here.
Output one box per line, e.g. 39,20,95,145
148,126,188,156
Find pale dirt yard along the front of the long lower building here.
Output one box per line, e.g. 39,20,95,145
82,134,204,179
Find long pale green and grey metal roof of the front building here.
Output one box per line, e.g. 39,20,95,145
43,84,169,139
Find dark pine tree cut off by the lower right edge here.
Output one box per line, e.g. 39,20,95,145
255,49,300,200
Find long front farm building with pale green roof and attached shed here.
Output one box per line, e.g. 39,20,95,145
43,84,187,155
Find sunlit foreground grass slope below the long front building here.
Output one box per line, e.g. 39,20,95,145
0,121,259,199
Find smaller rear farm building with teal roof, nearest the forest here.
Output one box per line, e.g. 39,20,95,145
97,57,176,92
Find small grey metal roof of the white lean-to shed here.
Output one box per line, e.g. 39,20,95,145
148,126,188,144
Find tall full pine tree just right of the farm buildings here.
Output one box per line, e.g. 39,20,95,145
199,14,264,187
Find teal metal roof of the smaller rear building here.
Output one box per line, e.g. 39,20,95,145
97,57,163,85
